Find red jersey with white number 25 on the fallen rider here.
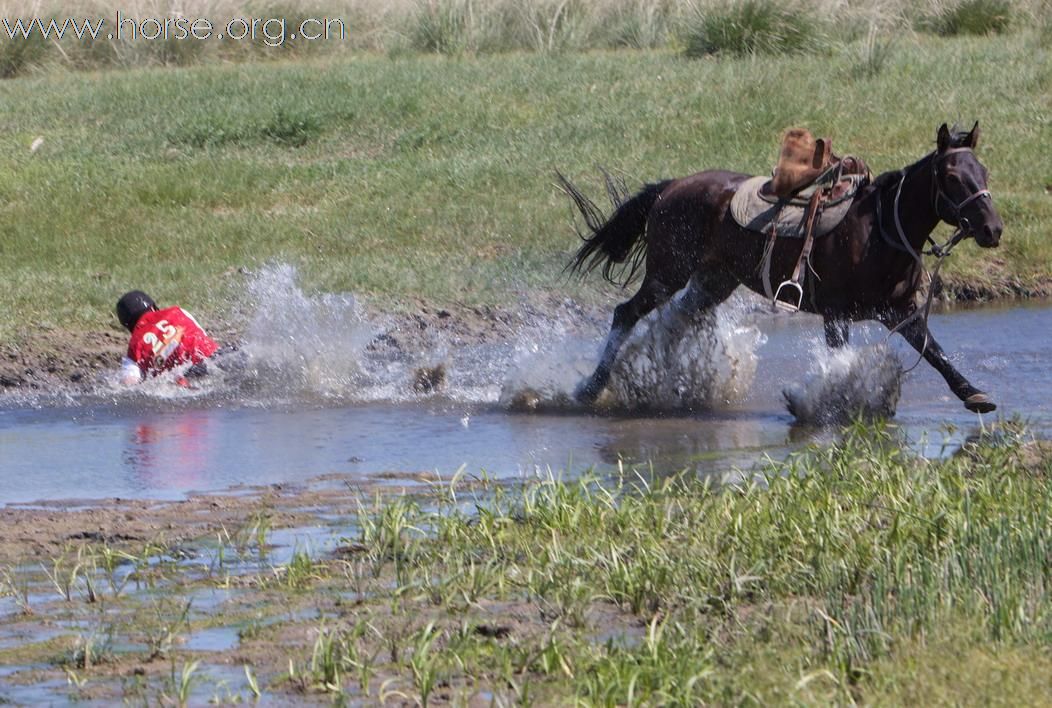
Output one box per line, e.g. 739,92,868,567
128,307,219,375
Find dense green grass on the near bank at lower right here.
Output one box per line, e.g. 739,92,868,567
378,420,1052,705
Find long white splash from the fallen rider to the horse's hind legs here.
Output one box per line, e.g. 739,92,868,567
57,264,763,410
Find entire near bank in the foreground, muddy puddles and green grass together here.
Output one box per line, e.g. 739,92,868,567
0,425,1052,706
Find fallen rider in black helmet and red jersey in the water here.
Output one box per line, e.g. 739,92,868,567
117,290,219,386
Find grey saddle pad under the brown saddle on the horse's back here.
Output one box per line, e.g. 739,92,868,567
730,175,863,239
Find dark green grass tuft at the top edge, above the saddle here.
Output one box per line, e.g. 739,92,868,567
685,0,824,57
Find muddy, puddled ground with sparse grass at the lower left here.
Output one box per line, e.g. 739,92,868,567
0,471,646,705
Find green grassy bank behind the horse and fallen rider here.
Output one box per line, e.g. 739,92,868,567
0,31,1052,341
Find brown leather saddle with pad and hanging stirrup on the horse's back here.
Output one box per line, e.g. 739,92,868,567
730,128,870,311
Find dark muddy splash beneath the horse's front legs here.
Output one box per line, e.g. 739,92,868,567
782,342,903,425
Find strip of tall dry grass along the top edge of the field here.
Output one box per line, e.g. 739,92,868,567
0,0,1050,78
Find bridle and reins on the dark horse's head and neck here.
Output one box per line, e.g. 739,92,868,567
876,147,993,373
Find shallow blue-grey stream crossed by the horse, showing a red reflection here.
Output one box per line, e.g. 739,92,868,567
0,275,1052,503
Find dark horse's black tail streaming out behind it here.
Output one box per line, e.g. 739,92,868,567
555,171,672,286
